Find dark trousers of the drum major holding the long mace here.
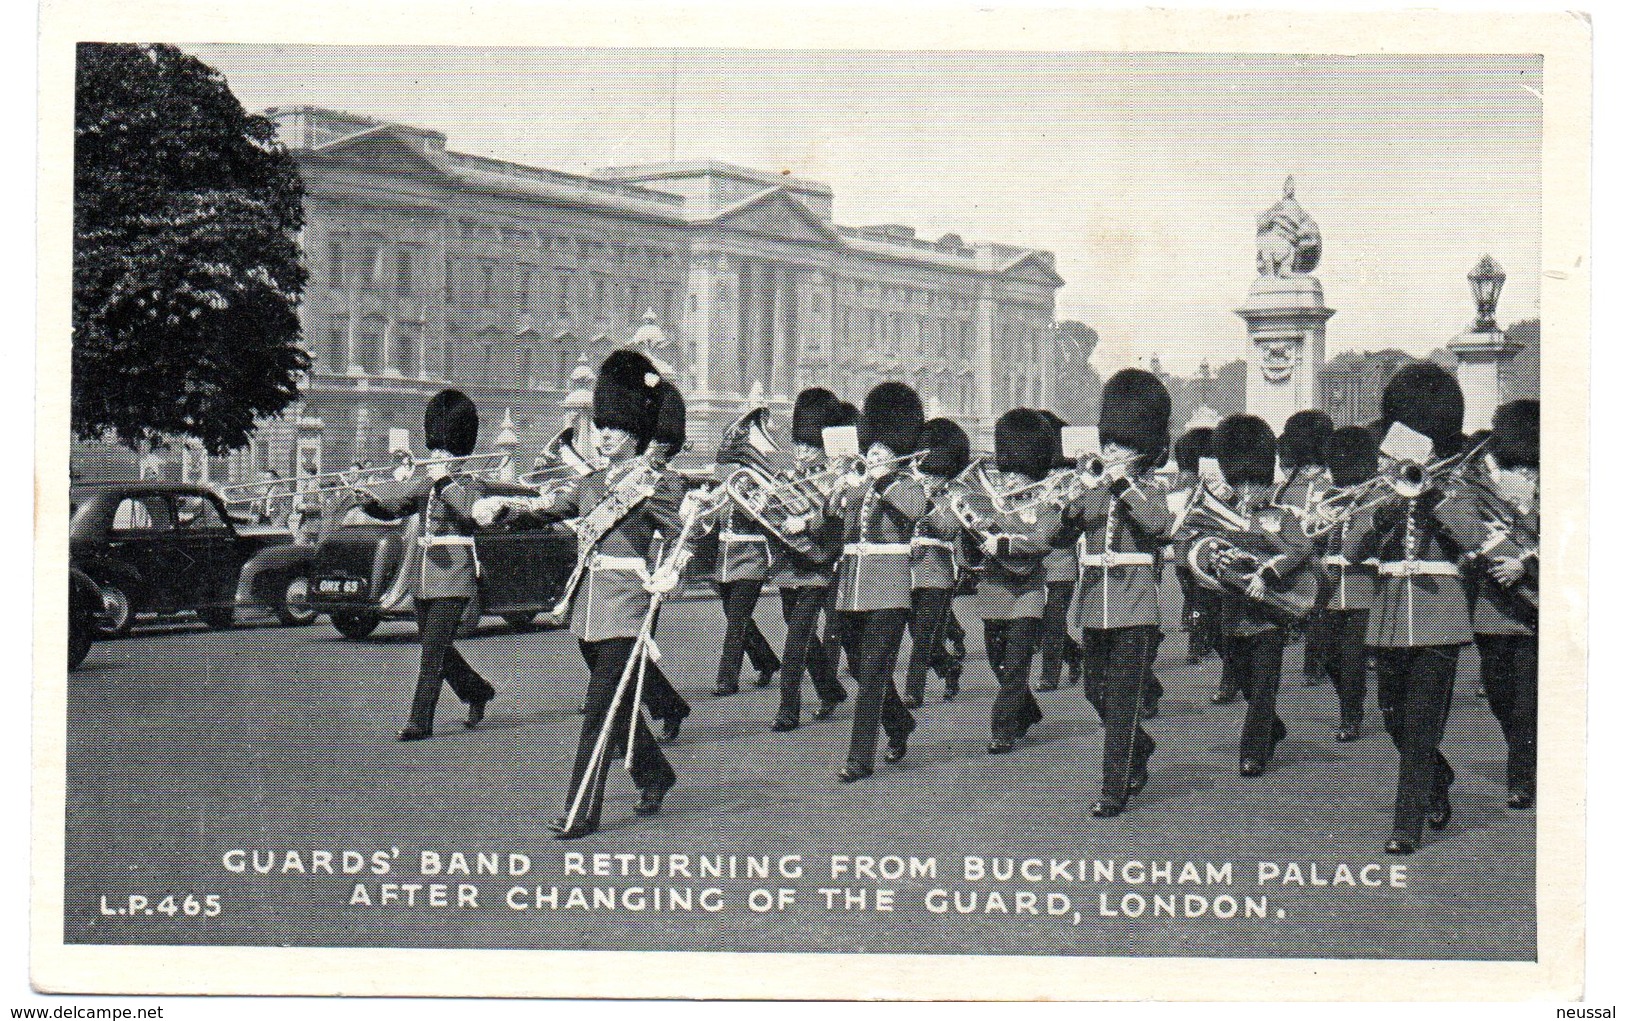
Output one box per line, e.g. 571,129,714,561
564,639,678,828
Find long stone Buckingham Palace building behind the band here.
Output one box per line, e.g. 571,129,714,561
232,106,1063,478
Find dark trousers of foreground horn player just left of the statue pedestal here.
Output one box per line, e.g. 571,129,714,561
1082,624,1157,805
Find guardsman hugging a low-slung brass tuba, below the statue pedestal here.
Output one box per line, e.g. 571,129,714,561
1212,415,1310,777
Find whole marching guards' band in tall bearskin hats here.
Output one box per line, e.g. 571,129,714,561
373,350,1539,854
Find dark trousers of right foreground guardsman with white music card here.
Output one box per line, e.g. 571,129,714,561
1376,645,1461,841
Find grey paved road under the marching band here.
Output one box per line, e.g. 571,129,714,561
65,598,1534,959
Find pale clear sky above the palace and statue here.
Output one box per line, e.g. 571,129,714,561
185,44,1542,374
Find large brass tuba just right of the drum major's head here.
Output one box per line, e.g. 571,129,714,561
717,408,839,564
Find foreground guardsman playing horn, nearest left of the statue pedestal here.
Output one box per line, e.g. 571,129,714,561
1063,369,1173,818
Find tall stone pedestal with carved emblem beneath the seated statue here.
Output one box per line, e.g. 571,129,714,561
1235,275,1336,434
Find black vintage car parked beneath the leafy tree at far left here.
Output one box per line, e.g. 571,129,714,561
68,481,309,637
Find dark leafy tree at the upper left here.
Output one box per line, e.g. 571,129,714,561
73,42,310,454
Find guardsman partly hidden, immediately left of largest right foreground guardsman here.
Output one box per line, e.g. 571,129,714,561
1316,426,1376,741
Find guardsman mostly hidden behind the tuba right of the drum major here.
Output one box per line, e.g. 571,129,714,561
712,422,780,697
